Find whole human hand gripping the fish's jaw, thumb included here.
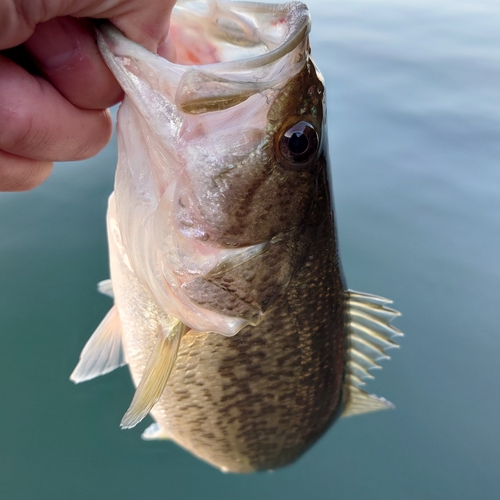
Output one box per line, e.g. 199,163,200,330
0,0,175,191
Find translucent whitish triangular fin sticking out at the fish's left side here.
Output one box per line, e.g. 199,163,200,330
70,306,126,384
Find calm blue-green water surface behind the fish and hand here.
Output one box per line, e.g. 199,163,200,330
0,0,500,500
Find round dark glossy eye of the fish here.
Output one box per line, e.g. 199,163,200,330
277,121,319,169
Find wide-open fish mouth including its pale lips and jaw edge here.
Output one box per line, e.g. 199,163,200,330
96,0,311,119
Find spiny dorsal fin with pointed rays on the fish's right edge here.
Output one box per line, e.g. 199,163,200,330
342,290,403,417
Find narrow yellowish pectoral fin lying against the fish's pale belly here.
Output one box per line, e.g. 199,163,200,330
120,320,188,429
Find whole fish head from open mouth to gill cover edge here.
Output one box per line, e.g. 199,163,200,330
98,1,326,335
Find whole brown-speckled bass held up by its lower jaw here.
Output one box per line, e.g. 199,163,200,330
71,0,402,473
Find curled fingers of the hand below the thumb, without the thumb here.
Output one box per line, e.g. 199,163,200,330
0,18,116,191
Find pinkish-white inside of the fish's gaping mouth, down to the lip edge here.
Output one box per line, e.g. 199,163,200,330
96,0,311,69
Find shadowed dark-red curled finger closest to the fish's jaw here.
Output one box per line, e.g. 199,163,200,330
24,17,123,109
